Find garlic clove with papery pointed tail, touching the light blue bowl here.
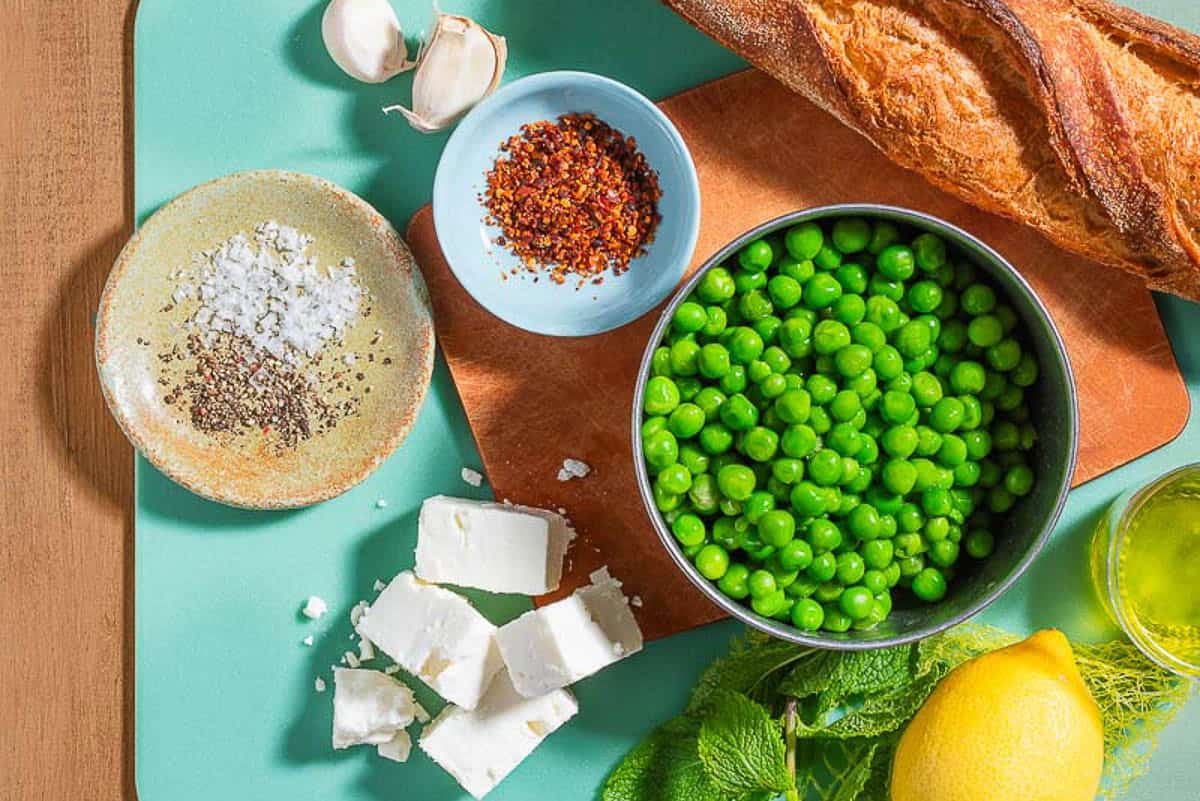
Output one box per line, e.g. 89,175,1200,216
384,6,509,133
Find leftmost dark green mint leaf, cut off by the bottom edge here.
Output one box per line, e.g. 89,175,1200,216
600,716,726,801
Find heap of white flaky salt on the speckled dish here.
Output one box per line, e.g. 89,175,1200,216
173,221,362,363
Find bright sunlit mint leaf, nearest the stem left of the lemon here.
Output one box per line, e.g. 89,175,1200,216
697,689,792,797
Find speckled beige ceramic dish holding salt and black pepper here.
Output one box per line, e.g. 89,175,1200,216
96,171,433,508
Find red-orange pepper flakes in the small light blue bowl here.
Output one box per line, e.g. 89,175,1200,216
484,114,662,284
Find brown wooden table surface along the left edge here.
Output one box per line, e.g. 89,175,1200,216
0,0,137,801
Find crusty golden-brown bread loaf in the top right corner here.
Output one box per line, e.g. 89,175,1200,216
666,0,1200,300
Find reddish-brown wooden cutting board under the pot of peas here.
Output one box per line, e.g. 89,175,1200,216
407,71,1189,639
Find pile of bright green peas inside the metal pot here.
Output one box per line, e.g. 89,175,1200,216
641,217,1038,632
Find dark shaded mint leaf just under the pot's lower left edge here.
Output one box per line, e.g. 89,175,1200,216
688,633,824,712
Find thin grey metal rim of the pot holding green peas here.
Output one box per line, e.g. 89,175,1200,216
631,203,1079,651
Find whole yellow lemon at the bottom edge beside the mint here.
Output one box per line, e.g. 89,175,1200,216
892,630,1104,801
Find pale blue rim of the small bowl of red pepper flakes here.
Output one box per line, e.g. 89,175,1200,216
431,70,701,338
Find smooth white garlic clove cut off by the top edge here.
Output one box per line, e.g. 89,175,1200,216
320,0,415,84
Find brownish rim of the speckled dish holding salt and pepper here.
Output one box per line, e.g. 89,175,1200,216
92,168,437,511
